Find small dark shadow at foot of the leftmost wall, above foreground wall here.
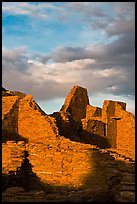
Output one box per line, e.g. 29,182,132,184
2,129,28,143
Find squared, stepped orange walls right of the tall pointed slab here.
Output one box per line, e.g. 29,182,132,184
81,100,135,159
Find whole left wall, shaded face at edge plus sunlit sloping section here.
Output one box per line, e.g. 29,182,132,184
2,95,59,142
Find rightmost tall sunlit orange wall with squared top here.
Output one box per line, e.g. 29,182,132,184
102,100,135,158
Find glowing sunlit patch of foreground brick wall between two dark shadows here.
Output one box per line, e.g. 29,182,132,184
27,137,92,187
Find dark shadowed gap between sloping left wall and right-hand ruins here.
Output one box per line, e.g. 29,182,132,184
50,112,110,148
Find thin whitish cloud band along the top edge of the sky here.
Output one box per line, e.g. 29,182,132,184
2,2,135,26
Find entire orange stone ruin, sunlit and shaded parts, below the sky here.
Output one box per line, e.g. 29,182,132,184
2,86,135,202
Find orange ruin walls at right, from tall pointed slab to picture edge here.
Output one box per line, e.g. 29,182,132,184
58,86,135,158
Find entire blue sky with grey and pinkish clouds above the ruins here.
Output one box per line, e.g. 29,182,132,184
2,2,135,113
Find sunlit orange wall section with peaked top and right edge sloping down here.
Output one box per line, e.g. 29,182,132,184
18,95,58,142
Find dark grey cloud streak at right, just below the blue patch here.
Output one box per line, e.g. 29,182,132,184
51,32,135,69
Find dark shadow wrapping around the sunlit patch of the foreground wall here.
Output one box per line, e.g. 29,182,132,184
2,149,134,202
